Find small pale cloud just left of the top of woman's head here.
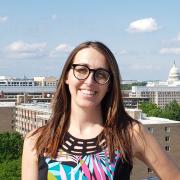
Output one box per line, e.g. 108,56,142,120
50,44,74,57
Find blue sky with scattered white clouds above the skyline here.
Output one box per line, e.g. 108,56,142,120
0,0,180,80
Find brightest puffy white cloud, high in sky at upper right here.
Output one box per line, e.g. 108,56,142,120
128,17,159,32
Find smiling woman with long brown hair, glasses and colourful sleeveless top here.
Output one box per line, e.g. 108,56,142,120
22,42,180,180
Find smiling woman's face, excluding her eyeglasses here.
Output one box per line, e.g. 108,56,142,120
66,47,109,108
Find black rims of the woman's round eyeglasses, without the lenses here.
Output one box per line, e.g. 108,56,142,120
70,64,111,85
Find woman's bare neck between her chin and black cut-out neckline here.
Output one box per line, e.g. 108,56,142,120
68,106,103,138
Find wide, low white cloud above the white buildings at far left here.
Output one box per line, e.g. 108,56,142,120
5,41,47,58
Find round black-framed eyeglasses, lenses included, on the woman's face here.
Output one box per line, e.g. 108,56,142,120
71,64,110,85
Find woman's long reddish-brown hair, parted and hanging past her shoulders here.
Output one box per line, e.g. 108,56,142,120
32,41,136,163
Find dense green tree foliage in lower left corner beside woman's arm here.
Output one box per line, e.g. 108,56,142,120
0,132,23,180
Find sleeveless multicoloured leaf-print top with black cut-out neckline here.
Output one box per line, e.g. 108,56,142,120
39,132,132,180
